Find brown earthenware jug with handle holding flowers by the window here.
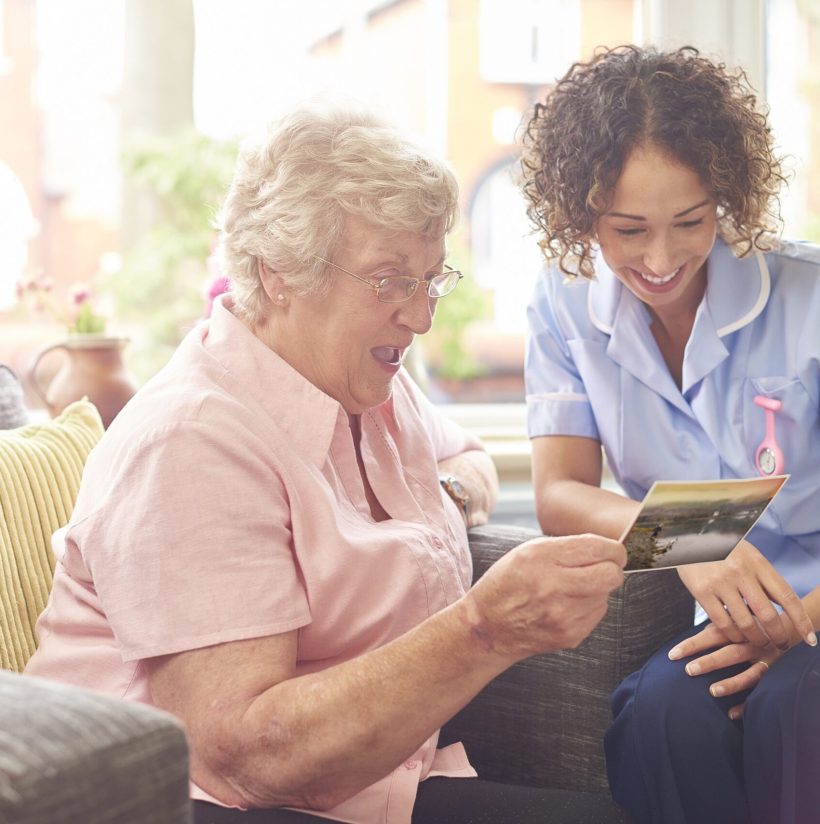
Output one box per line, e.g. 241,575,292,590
28,334,137,427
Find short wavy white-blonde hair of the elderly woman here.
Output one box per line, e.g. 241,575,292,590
218,101,458,322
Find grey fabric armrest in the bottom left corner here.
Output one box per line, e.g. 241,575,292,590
0,671,191,824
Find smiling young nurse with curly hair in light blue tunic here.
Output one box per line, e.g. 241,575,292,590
522,46,820,824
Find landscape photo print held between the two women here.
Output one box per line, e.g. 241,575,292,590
621,475,789,572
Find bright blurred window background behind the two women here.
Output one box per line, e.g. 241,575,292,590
0,0,820,520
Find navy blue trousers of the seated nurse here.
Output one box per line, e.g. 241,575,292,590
604,624,820,824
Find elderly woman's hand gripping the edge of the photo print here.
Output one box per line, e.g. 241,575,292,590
465,535,626,661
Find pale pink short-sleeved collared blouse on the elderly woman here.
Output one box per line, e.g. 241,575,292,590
26,296,480,824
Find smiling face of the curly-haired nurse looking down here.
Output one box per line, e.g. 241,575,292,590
597,147,717,316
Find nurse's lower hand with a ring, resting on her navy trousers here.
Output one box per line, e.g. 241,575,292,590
669,619,794,720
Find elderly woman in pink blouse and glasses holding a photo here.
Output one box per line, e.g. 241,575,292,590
28,107,625,822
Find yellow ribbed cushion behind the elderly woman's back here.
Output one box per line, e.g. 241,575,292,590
0,400,103,672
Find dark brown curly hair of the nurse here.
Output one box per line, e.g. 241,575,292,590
521,46,785,278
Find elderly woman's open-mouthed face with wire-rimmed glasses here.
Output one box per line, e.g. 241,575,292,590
274,218,445,415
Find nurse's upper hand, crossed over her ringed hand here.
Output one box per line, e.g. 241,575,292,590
678,541,816,649
